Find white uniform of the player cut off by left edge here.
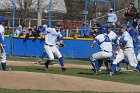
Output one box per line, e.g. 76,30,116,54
0,25,6,63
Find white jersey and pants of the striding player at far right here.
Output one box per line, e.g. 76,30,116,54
113,31,138,68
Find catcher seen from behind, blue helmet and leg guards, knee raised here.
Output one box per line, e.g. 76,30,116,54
90,26,114,74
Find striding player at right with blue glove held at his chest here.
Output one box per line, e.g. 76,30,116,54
110,25,140,76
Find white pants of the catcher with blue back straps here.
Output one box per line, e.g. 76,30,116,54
90,51,112,61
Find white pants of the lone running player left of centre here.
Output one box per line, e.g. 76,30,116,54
44,45,62,60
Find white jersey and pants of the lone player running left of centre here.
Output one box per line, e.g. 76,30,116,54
44,28,62,60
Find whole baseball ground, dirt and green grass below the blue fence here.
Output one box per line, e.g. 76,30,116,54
0,57,140,93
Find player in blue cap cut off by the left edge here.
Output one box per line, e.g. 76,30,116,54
0,16,6,71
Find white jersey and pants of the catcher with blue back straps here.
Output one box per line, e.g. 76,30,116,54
91,31,116,61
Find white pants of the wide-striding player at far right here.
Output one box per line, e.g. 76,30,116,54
113,48,138,68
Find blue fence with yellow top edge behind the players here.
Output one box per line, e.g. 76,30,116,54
5,37,99,58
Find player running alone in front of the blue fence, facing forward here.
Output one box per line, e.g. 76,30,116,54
41,22,67,71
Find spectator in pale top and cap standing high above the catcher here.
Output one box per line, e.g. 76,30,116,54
107,8,117,27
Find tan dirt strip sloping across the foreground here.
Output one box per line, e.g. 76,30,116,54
0,71,140,92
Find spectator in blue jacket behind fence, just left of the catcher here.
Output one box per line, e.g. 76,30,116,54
80,21,92,37
